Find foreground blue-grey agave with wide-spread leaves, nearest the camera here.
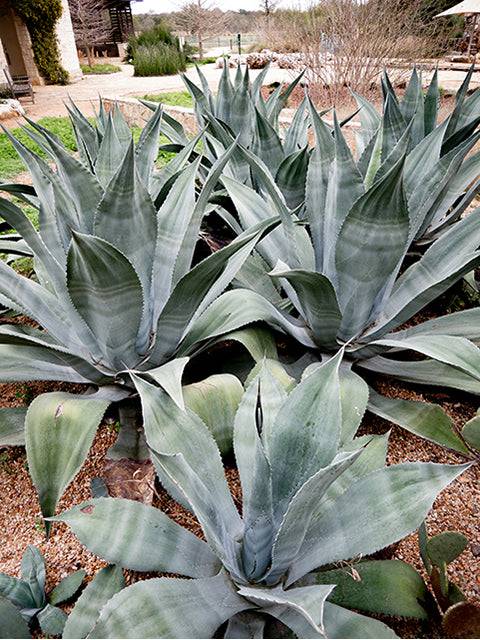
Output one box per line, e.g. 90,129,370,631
53,354,468,638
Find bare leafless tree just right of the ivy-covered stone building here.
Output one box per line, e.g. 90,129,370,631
68,0,112,67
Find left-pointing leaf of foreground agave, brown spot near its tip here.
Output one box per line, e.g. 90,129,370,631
50,498,221,578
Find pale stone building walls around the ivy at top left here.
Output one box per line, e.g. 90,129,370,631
0,0,82,85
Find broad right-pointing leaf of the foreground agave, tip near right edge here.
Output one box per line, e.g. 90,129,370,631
287,463,470,584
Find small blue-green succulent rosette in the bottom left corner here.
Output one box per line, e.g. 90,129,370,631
0,545,86,638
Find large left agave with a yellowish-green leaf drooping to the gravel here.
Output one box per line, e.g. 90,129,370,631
0,106,277,515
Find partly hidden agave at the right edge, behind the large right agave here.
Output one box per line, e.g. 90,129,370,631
355,66,480,245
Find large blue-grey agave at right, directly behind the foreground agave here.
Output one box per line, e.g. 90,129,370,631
180,96,480,453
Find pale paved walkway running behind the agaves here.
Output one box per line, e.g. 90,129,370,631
6,64,480,126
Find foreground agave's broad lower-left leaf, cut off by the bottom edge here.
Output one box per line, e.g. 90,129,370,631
88,573,249,638
